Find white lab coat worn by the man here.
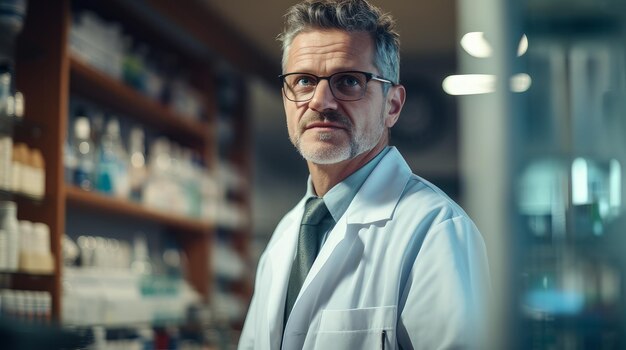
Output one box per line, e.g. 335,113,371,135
239,148,489,350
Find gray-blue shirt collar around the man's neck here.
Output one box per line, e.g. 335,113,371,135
305,146,391,222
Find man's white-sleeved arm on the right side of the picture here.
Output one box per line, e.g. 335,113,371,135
397,216,490,350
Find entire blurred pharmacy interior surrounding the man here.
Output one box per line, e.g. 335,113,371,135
0,0,626,349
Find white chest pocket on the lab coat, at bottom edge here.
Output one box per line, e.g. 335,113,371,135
315,306,396,350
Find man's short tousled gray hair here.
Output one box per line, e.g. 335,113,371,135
278,0,400,83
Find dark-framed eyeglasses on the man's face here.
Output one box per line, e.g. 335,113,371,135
278,71,396,102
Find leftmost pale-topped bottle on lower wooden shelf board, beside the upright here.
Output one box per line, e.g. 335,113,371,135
73,111,95,191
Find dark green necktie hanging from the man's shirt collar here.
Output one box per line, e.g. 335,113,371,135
283,198,334,325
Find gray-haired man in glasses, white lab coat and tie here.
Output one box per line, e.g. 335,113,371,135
239,0,489,349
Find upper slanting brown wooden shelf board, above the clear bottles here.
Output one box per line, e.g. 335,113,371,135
70,56,210,145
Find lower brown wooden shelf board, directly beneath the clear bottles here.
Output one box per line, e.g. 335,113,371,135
65,186,213,234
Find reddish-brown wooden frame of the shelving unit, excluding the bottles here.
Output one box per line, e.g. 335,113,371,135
11,0,260,321
